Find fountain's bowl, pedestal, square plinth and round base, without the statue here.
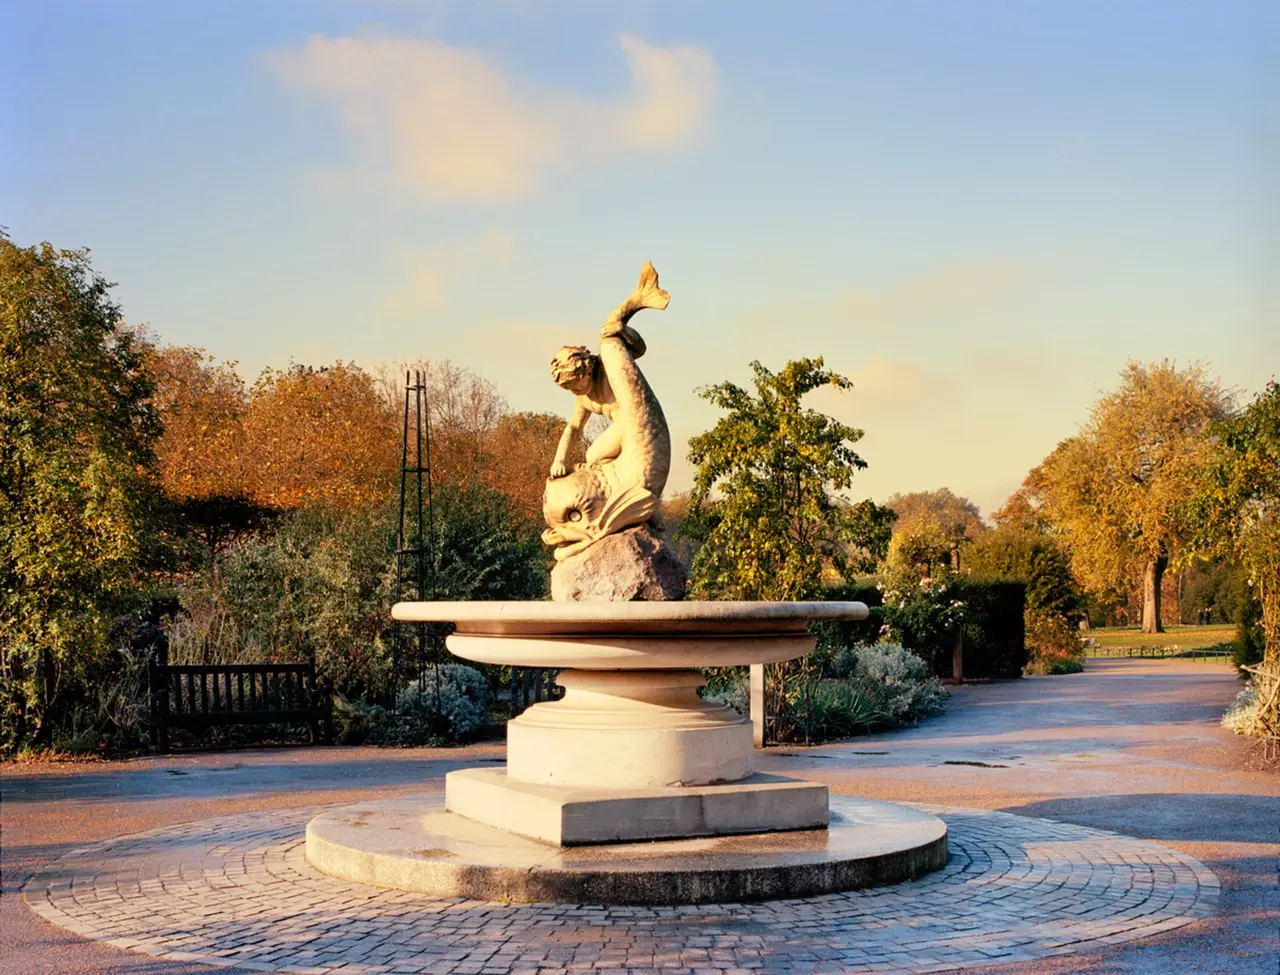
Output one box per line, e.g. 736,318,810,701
307,601,947,903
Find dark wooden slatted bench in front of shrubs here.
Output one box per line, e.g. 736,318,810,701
147,658,333,751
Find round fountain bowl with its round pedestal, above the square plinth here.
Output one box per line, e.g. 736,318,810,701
392,601,867,788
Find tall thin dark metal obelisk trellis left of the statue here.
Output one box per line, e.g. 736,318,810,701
390,370,444,714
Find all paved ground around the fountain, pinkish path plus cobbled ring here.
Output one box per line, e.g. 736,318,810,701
0,662,1280,975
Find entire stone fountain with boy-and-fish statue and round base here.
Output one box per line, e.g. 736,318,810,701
306,264,947,903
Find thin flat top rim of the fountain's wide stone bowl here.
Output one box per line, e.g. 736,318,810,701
392,600,868,623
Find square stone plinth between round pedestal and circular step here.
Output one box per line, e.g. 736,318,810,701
444,769,828,846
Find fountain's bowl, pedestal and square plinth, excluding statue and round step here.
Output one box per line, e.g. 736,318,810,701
412,603,849,846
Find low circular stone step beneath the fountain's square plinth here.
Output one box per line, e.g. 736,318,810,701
306,796,947,905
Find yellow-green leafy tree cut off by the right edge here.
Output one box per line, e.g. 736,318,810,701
1193,381,1280,667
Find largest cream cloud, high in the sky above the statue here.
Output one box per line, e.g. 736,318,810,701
266,35,716,201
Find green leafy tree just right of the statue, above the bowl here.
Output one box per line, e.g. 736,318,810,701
689,358,867,600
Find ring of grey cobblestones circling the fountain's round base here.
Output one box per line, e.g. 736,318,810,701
26,807,1219,975
